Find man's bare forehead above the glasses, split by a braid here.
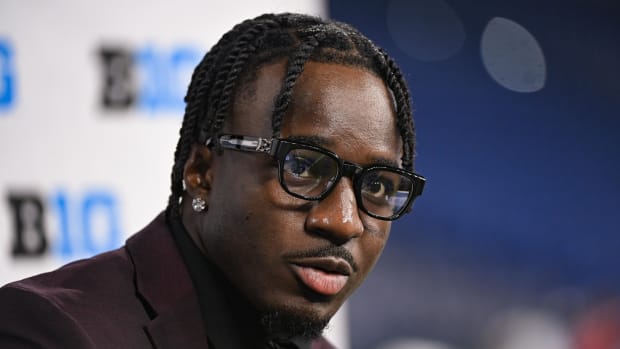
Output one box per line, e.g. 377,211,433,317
232,61,402,163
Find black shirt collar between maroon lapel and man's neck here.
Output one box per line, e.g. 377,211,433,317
166,212,310,349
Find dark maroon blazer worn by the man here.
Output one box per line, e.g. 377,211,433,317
0,214,333,349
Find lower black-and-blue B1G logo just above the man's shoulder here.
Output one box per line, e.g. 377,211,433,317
6,190,121,258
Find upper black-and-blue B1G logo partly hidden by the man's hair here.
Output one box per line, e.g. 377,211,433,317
99,46,201,114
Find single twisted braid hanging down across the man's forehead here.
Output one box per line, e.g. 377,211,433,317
271,35,323,137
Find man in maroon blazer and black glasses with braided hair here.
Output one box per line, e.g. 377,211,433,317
0,14,424,349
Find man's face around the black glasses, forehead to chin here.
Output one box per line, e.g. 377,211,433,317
198,62,402,336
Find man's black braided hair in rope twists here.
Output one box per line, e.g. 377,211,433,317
168,13,415,215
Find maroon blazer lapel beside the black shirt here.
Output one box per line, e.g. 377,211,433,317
127,213,208,349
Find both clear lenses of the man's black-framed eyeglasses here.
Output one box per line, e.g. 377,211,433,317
281,148,413,218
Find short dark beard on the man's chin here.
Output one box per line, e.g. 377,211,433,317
260,308,330,341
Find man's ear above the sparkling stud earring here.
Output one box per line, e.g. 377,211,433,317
183,144,213,200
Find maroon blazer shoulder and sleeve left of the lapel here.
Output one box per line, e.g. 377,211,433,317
0,213,167,348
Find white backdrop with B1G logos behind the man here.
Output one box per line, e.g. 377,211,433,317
0,0,348,348
